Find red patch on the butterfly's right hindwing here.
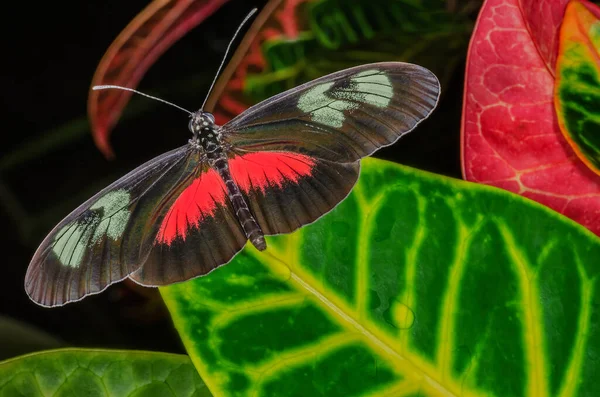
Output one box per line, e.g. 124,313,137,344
229,152,316,193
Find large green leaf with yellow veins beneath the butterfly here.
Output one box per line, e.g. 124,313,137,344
161,159,600,397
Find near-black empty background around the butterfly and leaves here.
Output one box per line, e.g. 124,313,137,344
0,0,464,358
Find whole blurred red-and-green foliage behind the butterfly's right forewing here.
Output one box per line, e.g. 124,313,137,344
207,0,470,123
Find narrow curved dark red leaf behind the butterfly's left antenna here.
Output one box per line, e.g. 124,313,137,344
88,0,228,157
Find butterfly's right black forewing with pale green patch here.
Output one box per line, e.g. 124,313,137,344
222,62,440,163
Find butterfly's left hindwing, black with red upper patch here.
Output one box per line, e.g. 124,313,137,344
130,164,247,286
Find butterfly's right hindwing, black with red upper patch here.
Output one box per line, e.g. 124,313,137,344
229,152,360,234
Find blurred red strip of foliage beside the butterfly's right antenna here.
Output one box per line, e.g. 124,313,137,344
205,0,311,124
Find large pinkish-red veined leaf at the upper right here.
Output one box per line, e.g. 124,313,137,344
461,0,600,234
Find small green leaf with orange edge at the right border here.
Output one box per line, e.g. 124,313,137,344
554,0,600,174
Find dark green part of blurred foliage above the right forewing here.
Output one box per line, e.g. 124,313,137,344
245,0,472,102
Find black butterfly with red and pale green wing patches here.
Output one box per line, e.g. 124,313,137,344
25,62,440,306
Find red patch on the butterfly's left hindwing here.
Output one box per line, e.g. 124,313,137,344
156,169,226,245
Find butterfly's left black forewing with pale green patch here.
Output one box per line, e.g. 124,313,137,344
25,145,199,306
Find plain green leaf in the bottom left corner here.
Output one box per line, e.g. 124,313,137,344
0,349,212,397
